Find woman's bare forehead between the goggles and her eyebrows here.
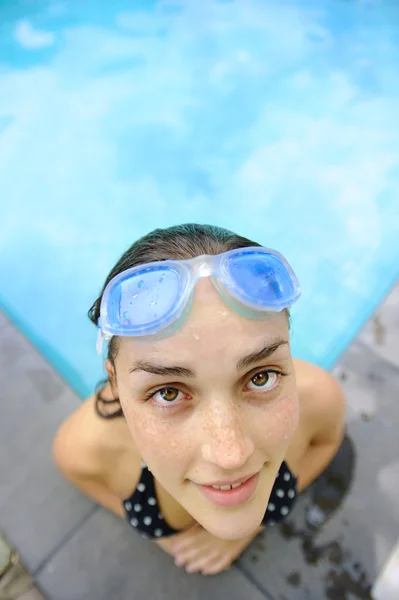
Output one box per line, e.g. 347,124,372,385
118,278,288,364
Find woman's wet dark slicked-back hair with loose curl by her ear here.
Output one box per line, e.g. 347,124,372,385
88,223,288,419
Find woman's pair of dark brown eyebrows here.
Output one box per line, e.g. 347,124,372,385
129,338,288,379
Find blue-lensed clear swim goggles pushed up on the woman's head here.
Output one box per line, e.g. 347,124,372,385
97,246,301,354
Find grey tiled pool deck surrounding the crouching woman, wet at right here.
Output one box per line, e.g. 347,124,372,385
0,287,399,600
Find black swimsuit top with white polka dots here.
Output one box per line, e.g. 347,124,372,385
123,462,298,540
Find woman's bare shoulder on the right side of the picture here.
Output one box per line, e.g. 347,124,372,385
294,359,346,443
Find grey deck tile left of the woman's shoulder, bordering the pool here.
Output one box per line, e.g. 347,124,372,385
0,315,95,572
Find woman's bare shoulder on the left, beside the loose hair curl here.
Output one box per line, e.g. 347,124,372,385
53,386,133,476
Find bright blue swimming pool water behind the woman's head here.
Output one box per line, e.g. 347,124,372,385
0,0,399,396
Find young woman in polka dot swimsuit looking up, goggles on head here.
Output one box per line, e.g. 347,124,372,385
54,225,345,574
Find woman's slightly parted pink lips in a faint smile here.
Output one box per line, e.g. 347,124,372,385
196,473,260,506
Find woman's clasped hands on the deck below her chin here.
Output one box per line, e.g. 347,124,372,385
172,524,263,575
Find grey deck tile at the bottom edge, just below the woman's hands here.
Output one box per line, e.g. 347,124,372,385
38,509,265,600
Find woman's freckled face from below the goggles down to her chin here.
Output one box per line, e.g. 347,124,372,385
111,278,298,539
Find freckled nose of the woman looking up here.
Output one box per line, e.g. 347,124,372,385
202,400,254,470
